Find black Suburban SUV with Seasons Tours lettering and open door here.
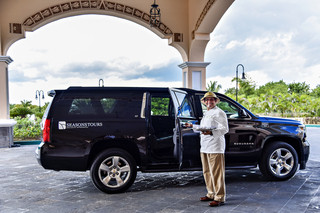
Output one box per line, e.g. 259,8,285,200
36,87,309,193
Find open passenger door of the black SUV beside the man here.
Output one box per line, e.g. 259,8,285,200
169,88,201,169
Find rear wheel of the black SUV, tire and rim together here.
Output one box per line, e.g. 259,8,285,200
90,149,137,194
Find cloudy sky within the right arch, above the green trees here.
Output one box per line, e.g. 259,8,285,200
206,0,320,88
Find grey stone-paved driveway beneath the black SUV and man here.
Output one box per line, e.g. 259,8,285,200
0,128,320,213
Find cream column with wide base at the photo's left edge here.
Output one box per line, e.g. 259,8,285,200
0,56,16,148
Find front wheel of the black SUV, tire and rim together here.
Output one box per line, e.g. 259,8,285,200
259,141,298,180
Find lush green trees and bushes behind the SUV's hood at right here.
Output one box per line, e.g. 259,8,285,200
225,78,320,117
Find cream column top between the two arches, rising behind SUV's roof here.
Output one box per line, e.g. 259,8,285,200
179,62,210,90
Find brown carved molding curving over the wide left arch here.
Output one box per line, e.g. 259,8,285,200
23,0,173,36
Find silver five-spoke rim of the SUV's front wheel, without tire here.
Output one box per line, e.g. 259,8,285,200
269,148,294,177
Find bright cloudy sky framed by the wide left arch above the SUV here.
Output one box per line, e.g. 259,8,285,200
9,15,181,102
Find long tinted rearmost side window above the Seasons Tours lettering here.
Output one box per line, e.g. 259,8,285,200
54,92,142,119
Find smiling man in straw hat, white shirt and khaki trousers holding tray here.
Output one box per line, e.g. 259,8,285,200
187,92,229,207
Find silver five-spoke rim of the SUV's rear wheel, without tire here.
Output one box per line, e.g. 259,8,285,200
99,156,131,188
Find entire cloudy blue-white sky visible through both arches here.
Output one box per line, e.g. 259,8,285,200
7,0,320,105
